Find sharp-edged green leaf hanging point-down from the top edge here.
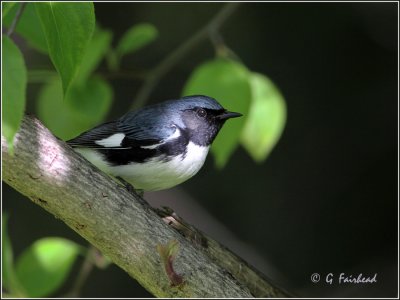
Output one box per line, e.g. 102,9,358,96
35,2,95,94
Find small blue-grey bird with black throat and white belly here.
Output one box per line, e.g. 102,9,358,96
67,95,242,192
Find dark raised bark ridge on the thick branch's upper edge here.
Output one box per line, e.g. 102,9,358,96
153,206,207,248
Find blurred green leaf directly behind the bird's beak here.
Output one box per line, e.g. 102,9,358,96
183,58,251,168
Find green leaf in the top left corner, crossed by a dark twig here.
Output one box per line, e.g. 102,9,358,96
3,3,48,54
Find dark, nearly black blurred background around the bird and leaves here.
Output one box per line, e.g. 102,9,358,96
3,2,398,297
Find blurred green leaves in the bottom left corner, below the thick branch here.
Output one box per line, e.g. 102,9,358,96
2,214,85,297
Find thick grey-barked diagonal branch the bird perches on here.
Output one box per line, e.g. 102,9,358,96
1,116,286,298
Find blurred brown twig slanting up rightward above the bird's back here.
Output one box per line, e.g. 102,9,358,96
131,2,240,109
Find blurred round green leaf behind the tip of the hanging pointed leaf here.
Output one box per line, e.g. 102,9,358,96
37,77,112,139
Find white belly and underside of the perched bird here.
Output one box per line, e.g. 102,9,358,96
76,142,209,191
